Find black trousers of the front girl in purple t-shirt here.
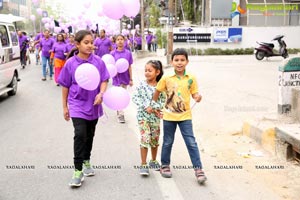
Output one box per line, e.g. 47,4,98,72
72,118,98,171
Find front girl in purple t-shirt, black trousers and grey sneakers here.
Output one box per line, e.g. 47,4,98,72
58,30,109,187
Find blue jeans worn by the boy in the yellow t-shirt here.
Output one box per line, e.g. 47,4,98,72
161,120,202,169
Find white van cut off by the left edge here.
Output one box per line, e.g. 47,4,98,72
0,14,21,96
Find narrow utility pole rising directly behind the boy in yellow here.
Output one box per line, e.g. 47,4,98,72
167,0,174,65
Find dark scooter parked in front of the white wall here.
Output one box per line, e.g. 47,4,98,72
255,35,289,60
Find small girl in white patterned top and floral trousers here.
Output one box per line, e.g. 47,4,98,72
132,60,165,176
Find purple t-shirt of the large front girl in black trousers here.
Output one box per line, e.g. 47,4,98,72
58,54,109,120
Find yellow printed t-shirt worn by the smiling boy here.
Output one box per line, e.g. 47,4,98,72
156,73,198,121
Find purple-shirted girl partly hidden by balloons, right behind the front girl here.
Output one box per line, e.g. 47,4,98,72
110,35,133,123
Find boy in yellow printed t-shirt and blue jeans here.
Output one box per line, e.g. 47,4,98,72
152,49,207,184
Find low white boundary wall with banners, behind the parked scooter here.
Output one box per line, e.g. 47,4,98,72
173,26,300,49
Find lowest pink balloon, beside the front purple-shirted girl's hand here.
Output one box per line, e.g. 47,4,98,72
103,86,130,110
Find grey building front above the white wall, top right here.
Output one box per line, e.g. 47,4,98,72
204,0,300,27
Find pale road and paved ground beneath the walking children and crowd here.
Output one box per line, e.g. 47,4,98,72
0,56,300,200
